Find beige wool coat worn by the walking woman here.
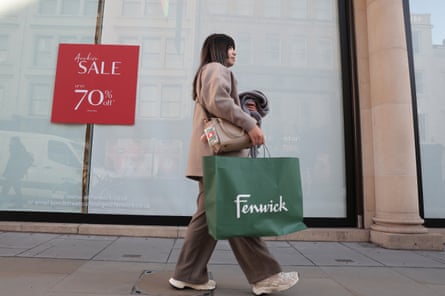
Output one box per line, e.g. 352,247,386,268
186,62,257,179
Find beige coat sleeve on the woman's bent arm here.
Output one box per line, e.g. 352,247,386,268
199,63,257,131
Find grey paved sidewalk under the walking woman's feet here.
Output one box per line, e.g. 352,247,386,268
0,232,445,296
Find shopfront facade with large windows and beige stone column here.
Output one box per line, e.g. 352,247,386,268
0,0,445,249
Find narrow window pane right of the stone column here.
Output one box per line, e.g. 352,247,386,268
409,0,445,218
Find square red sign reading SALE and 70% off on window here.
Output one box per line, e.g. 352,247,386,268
51,44,139,125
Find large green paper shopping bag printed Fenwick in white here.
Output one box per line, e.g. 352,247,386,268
203,156,306,239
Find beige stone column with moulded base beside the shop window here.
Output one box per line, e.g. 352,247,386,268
366,0,443,249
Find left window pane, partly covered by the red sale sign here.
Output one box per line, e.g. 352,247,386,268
0,0,98,212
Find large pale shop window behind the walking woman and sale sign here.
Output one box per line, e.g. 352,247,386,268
0,0,346,217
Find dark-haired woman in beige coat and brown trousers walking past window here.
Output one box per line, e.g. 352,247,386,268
169,34,299,295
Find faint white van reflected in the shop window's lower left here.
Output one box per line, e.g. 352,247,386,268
0,131,82,211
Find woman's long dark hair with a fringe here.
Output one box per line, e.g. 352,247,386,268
192,34,235,100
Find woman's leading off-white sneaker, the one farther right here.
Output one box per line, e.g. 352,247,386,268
252,271,299,295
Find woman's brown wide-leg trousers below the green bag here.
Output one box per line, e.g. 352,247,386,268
173,179,281,284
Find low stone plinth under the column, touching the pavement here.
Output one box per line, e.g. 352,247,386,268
371,230,444,251
